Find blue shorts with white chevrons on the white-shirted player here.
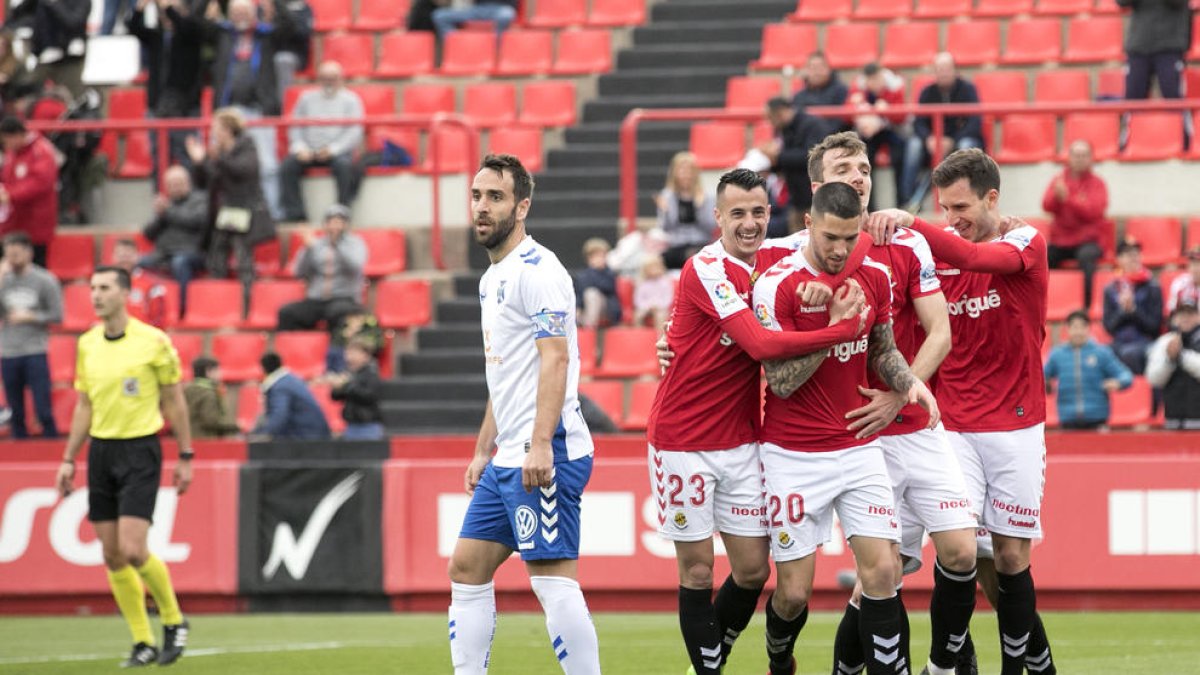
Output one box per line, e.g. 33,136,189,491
458,455,592,560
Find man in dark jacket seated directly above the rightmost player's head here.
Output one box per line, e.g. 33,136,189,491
900,52,983,213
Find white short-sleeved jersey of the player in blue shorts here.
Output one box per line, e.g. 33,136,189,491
479,237,593,467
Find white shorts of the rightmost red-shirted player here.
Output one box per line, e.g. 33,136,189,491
947,424,1046,540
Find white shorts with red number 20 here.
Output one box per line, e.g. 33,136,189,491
760,443,900,562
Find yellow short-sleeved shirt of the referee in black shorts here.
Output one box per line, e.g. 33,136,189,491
74,317,182,440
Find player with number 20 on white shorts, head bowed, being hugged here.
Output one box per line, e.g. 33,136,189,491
754,183,938,675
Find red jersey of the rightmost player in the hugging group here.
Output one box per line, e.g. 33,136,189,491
935,226,1050,432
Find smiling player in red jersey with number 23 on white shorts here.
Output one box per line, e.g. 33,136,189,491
647,169,863,675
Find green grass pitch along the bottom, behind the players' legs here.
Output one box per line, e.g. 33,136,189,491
0,608,1200,675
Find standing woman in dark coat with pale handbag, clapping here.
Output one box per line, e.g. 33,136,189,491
187,106,275,305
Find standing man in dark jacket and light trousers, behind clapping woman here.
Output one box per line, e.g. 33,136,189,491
208,0,294,219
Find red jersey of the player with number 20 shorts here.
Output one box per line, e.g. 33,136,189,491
754,251,892,453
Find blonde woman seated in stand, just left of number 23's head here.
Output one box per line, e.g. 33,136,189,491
654,153,716,269
